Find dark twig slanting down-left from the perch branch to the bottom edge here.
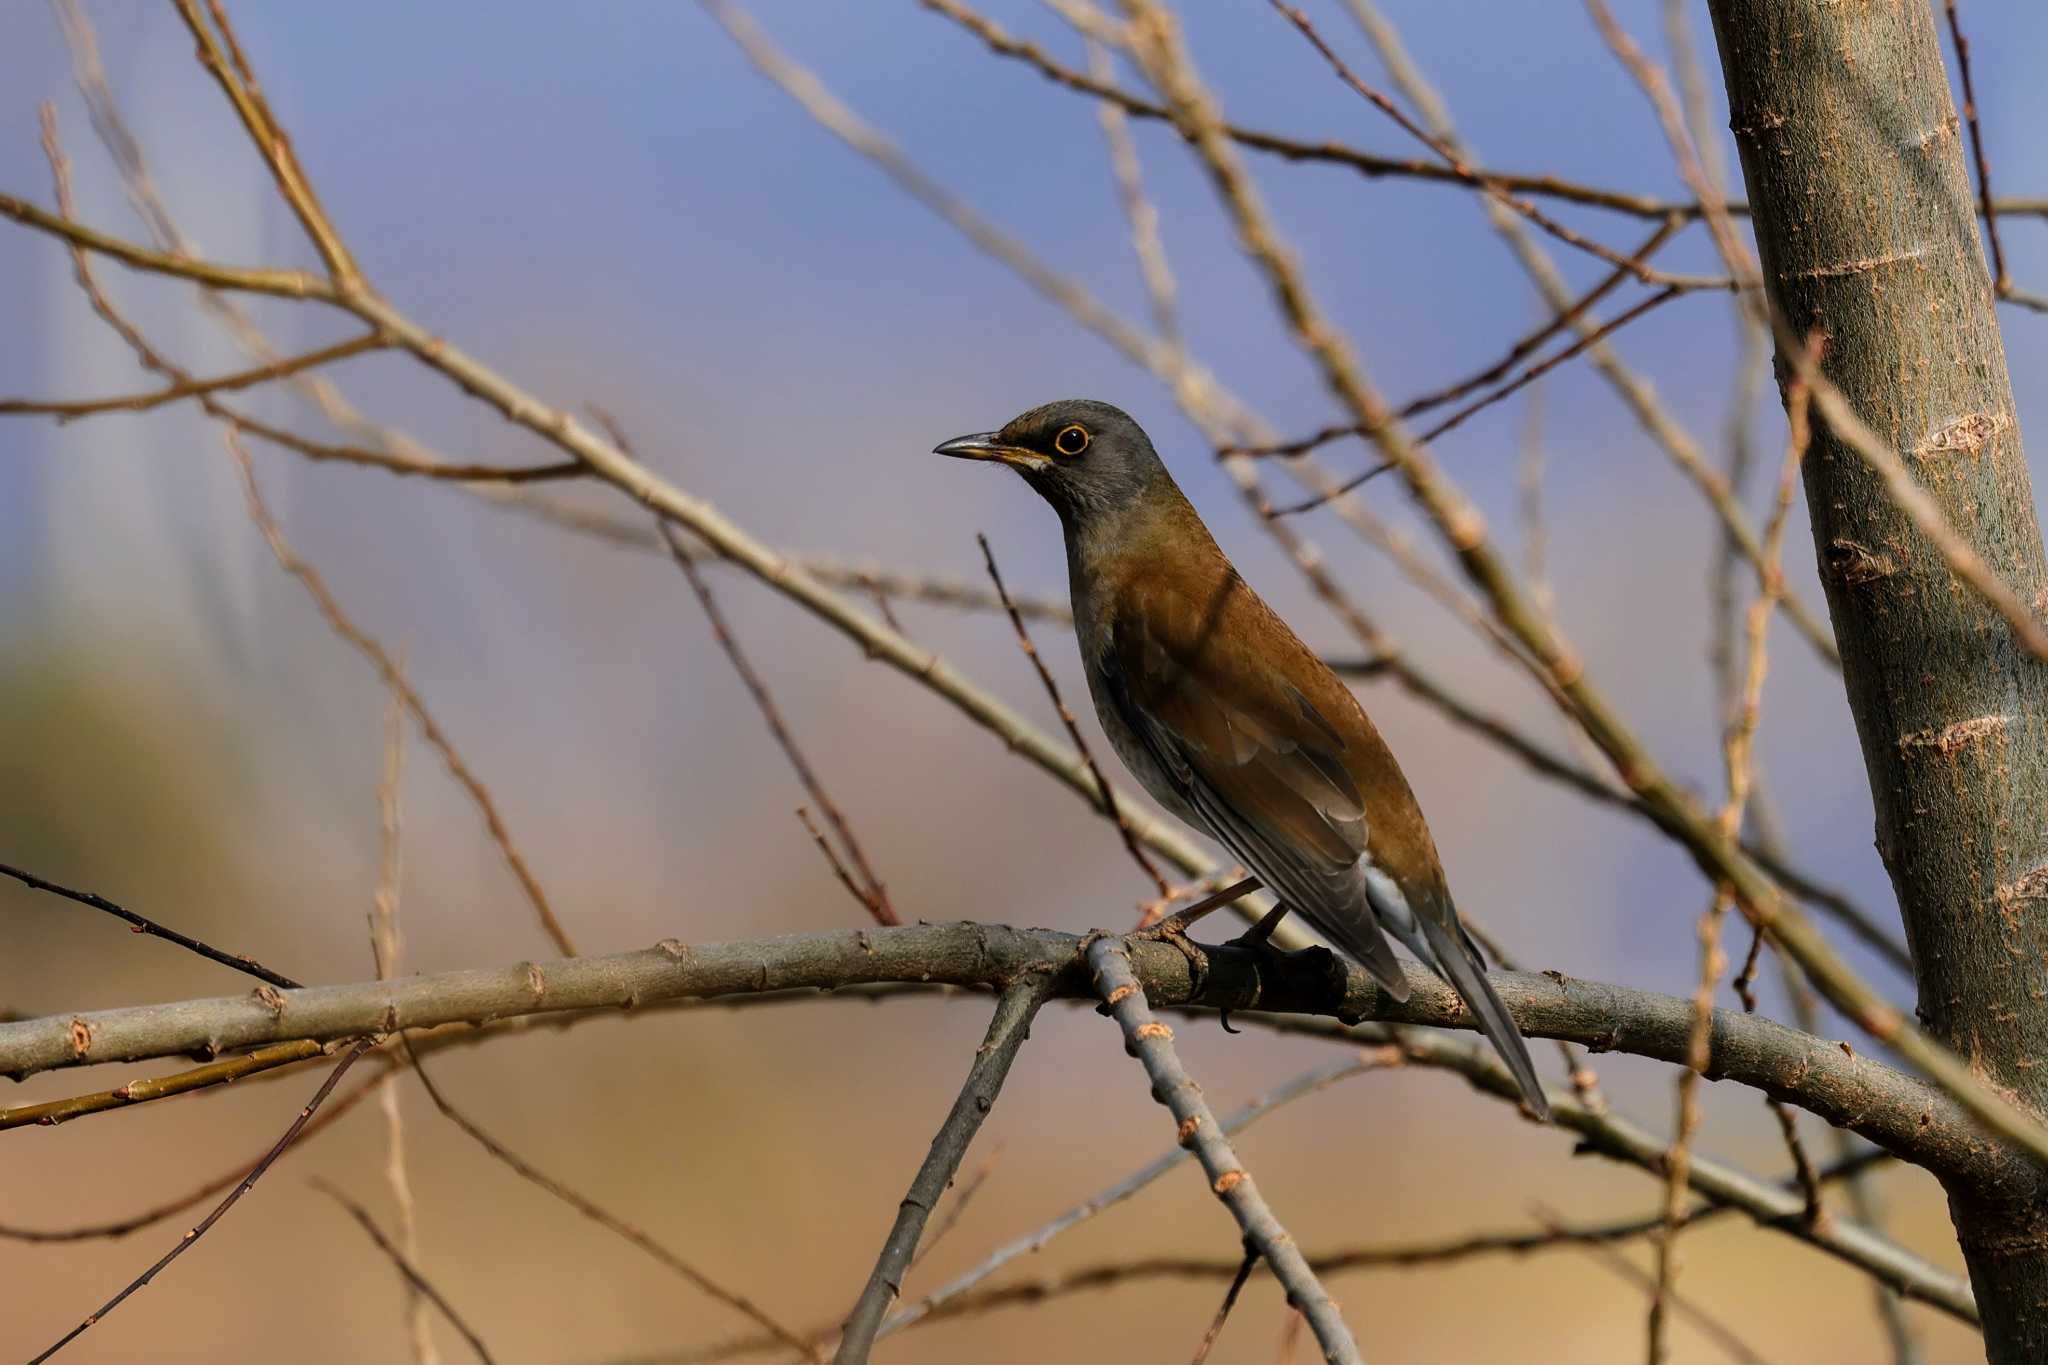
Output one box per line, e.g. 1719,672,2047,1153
831,972,1053,1365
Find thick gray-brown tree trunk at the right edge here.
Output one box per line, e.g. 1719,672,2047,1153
1712,0,2048,1365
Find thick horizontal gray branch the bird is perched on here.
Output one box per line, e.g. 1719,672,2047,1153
0,923,2048,1199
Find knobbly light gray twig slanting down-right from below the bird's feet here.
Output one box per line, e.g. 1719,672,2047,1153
1087,937,1360,1365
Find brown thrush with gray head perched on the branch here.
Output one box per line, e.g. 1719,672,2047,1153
934,399,1550,1121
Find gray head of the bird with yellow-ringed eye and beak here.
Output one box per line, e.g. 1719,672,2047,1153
936,399,1171,528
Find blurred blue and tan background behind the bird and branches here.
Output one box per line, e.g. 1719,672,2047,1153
0,0,2048,1365
